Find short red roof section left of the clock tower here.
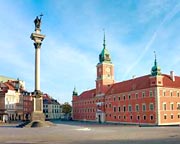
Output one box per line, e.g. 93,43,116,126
78,89,96,100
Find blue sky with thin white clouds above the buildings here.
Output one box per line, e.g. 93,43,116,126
0,0,180,103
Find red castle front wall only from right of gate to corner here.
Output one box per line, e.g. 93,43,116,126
105,88,156,124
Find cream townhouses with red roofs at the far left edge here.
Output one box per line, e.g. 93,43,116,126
0,79,24,122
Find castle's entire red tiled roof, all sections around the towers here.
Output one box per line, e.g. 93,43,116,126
75,74,180,100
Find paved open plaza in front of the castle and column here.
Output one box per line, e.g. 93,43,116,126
0,122,180,144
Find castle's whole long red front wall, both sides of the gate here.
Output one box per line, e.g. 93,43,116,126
72,88,157,124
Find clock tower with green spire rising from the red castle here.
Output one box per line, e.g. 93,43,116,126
96,34,114,96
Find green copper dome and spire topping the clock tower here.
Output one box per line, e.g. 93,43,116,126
99,35,111,63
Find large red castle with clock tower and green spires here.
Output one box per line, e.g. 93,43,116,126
72,35,180,125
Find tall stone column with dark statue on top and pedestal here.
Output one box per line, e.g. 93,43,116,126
30,15,45,121
